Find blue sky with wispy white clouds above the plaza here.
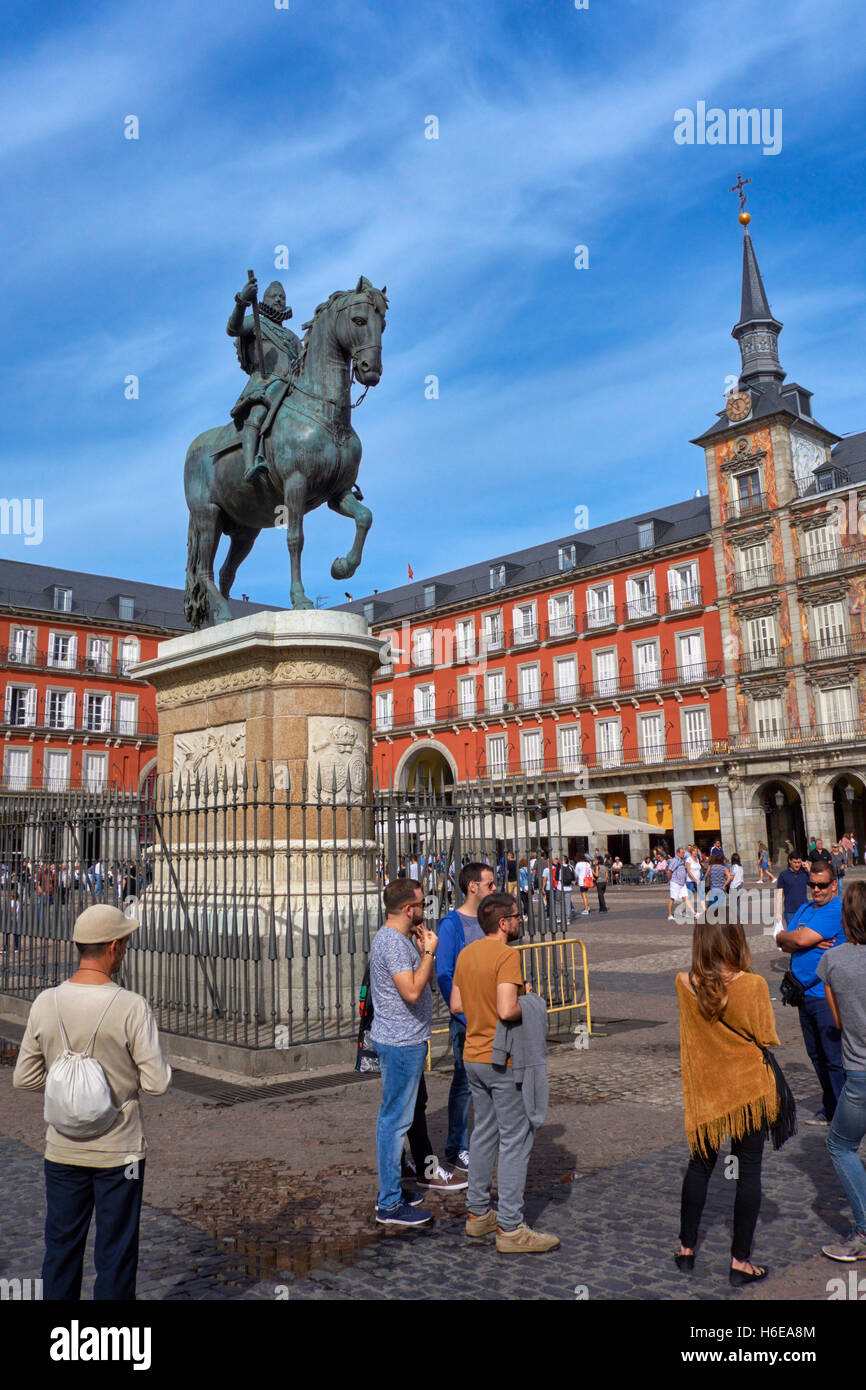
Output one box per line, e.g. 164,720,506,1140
0,0,866,603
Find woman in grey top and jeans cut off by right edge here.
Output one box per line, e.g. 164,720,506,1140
817,883,866,1261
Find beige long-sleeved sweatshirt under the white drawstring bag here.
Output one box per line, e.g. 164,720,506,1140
13,980,171,1168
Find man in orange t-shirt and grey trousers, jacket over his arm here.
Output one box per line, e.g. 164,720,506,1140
450,892,559,1254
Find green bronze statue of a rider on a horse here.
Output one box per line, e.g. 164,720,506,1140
183,271,388,628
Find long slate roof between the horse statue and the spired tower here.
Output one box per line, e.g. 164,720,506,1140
339,496,710,623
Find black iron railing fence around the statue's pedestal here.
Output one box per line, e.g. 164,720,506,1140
0,765,580,1048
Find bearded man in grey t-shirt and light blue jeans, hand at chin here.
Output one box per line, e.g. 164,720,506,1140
370,878,439,1226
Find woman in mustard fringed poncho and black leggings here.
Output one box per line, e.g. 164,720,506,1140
674,922,778,1284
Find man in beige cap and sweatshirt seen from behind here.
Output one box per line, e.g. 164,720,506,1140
13,904,171,1301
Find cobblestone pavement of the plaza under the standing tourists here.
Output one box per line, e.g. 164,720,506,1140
0,890,849,1301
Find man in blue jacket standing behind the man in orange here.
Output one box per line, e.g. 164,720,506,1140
436,863,496,1173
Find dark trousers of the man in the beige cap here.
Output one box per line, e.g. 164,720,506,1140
42,1158,145,1302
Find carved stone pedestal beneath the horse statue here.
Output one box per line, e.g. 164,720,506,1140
136,610,382,1045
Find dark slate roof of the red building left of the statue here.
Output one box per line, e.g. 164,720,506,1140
0,559,274,632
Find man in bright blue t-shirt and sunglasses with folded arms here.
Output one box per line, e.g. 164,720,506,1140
774,859,845,1125
